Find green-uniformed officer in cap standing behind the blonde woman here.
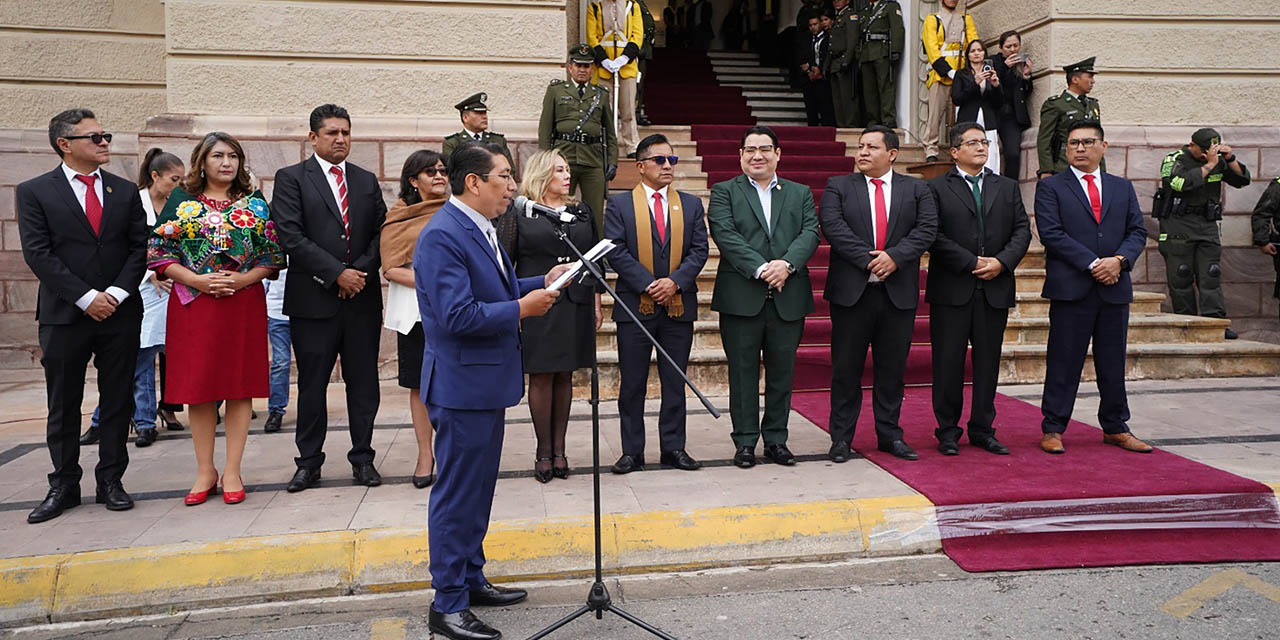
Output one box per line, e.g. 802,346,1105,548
538,42,618,229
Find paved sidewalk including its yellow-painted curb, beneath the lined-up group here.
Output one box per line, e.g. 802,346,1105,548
0,371,1280,625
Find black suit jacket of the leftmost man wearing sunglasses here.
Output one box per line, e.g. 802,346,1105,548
17,164,148,325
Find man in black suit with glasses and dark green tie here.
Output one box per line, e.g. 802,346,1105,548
924,122,1032,456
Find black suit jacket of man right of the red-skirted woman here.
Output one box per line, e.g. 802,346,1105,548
271,156,387,319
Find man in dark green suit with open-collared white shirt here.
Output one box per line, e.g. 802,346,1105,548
707,125,818,468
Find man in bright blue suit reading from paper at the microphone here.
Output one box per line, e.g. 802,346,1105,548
413,143,568,640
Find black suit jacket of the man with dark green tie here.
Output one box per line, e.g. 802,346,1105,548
924,169,1032,308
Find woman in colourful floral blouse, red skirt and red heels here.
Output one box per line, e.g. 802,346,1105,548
147,132,284,506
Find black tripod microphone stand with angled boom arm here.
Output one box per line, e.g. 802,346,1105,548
529,211,721,640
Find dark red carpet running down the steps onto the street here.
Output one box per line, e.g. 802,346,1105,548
665,52,1280,571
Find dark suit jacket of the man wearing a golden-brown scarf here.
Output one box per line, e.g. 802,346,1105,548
604,187,709,323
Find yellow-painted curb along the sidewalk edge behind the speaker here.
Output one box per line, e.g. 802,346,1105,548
0,495,941,623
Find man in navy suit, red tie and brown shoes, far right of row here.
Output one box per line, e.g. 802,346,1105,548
1036,120,1152,453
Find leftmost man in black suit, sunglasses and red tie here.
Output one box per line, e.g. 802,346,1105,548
17,109,147,524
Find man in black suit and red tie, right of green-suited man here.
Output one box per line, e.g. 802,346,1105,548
818,125,938,462
